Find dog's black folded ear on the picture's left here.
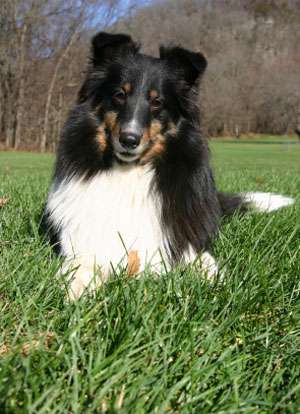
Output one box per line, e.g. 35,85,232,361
91,32,140,66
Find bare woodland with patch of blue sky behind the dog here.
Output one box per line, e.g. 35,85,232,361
0,0,300,152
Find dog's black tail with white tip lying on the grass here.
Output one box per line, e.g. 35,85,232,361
218,192,295,217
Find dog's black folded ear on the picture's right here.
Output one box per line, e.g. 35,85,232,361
159,46,207,87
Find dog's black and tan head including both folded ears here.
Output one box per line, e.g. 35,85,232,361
79,33,206,164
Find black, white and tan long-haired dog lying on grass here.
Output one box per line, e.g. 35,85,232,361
45,32,293,300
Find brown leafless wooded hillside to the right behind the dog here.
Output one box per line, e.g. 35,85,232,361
115,0,300,136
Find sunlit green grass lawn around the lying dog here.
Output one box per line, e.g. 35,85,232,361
0,142,300,414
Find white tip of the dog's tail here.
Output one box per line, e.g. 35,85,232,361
242,192,295,213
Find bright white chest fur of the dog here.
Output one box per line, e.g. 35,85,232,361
47,165,165,274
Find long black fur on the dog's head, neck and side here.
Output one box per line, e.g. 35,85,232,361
49,33,247,266
